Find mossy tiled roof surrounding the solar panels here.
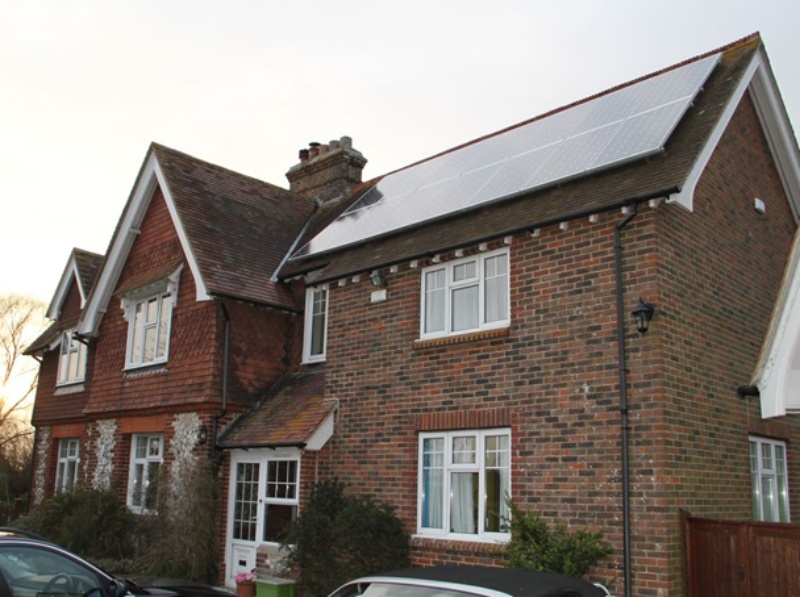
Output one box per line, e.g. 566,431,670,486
281,35,761,281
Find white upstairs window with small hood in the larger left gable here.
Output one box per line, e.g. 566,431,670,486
122,269,180,368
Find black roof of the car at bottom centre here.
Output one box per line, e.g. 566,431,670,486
352,566,606,597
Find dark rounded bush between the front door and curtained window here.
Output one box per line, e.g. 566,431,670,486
283,481,409,597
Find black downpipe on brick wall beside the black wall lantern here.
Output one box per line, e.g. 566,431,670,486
614,203,637,597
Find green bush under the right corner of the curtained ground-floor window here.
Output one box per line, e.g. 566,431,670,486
504,500,611,577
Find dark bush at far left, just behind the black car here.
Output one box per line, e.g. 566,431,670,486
16,486,136,562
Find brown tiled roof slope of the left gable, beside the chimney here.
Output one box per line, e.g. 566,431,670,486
152,144,313,310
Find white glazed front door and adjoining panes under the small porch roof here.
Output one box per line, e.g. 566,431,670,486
225,449,300,586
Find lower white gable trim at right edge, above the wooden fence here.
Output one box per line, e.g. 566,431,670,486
753,226,800,419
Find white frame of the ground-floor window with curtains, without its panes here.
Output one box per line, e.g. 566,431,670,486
417,428,512,542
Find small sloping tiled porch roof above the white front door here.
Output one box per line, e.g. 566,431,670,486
218,370,334,448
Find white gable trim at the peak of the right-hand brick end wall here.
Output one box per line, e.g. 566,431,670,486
668,48,800,220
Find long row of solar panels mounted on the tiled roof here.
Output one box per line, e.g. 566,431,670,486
297,54,719,256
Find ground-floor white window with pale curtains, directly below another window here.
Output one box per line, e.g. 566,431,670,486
417,429,511,539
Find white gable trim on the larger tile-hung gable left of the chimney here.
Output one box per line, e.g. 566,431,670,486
78,146,211,335
